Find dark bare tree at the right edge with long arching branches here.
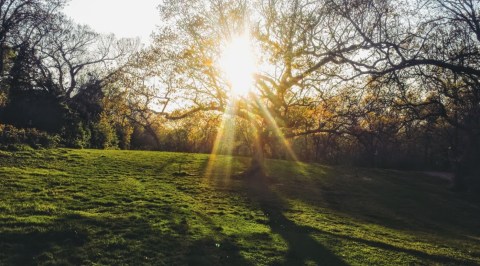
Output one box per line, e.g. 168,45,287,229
322,0,480,189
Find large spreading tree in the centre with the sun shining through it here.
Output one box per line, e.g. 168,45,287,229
146,0,365,176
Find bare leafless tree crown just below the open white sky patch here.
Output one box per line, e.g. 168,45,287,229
35,16,136,100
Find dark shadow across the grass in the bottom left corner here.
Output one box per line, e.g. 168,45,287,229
0,211,253,265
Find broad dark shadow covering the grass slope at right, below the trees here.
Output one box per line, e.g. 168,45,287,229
276,165,480,238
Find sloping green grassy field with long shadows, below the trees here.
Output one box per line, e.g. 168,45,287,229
0,149,480,265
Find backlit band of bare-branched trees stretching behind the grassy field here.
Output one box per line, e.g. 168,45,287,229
0,0,480,191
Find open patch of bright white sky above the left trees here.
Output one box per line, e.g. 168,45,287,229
64,0,160,43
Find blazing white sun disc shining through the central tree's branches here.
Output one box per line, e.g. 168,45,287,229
220,33,257,97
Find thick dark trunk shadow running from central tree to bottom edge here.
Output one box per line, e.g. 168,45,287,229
245,174,347,265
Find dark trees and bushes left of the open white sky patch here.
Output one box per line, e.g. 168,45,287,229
0,0,132,148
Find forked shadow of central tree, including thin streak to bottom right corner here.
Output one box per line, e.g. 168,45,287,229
238,169,477,265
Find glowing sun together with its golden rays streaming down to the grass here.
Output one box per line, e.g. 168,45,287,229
206,29,299,179
